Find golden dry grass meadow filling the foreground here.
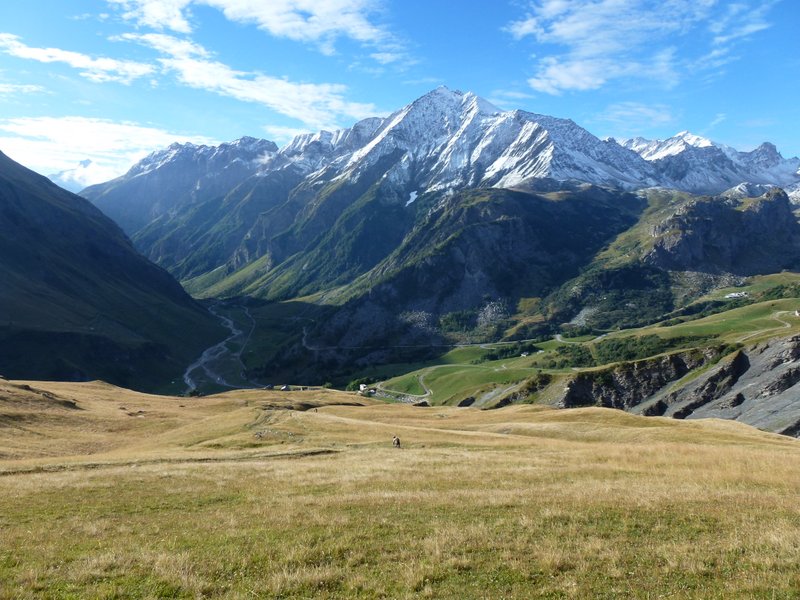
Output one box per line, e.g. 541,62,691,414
0,380,800,599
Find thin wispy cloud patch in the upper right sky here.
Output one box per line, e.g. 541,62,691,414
506,0,775,94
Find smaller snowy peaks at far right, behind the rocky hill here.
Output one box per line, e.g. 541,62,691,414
620,131,800,194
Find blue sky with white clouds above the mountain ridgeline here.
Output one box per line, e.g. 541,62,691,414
0,0,800,184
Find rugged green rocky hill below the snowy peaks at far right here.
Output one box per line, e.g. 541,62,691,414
548,188,800,329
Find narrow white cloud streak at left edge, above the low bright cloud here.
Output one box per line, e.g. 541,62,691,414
0,33,153,84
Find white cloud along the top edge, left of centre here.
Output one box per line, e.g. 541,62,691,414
107,0,402,56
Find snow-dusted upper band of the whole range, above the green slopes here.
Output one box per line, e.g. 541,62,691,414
83,87,800,223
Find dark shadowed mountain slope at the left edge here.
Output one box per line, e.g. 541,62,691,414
0,153,221,389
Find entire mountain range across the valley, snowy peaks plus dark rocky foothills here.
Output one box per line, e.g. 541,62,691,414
82,88,800,380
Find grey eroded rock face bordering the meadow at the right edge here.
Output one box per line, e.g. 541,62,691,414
559,336,800,437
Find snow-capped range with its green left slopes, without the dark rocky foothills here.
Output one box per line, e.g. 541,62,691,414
82,87,800,297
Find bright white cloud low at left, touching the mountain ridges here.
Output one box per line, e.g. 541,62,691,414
0,116,217,185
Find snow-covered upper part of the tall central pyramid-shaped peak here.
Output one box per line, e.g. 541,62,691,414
263,87,657,192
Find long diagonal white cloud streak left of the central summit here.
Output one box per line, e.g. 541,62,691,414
120,33,377,129
